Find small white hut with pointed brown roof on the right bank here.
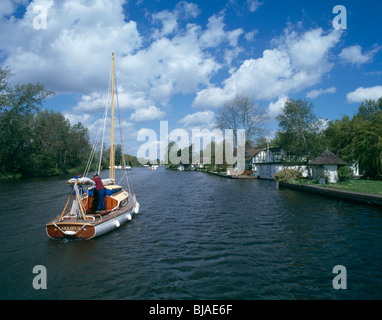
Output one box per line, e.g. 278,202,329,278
309,149,349,183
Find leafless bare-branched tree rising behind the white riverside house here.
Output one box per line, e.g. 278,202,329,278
215,96,268,142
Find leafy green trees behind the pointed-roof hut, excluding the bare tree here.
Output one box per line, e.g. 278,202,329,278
274,97,382,180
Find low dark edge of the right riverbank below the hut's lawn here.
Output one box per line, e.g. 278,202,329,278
279,182,382,207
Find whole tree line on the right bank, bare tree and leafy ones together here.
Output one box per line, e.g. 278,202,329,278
180,96,382,180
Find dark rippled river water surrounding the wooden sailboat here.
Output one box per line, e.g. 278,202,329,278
0,168,382,300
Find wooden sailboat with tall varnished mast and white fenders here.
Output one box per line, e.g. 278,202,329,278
46,53,139,240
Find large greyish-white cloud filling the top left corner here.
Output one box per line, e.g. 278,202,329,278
0,0,142,94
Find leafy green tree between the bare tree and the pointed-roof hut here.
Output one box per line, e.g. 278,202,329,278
276,99,325,165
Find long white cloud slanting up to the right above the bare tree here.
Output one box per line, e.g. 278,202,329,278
193,28,341,107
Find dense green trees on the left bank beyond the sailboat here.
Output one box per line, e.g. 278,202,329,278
0,69,89,178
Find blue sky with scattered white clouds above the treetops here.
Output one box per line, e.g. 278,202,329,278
0,0,382,160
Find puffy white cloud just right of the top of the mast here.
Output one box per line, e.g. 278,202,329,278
120,26,220,104
